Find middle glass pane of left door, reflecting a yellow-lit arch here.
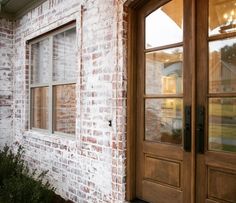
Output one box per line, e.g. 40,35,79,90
145,47,183,94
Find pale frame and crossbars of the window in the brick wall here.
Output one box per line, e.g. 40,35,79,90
27,21,77,137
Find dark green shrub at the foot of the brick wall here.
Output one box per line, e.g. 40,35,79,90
0,146,55,203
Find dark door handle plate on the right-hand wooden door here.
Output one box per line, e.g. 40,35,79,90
196,106,205,154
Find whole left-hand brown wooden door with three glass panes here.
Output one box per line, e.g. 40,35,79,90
136,0,193,203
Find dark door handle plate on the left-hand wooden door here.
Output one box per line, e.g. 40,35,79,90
184,106,192,152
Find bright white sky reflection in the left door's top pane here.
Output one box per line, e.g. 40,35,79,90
146,9,183,48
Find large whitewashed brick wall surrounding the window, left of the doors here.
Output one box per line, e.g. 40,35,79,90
3,0,127,202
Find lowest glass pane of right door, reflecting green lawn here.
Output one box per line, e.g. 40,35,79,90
208,98,236,152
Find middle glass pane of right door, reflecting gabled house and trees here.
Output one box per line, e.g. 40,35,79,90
209,38,236,93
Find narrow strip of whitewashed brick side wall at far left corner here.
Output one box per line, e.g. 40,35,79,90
0,18,13,149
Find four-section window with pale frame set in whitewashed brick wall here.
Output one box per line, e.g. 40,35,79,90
30,26,77,134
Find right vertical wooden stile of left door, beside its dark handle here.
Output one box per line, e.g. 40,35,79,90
183,0,196,203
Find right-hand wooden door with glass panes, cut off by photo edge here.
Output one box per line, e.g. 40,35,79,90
196,0,236,203
